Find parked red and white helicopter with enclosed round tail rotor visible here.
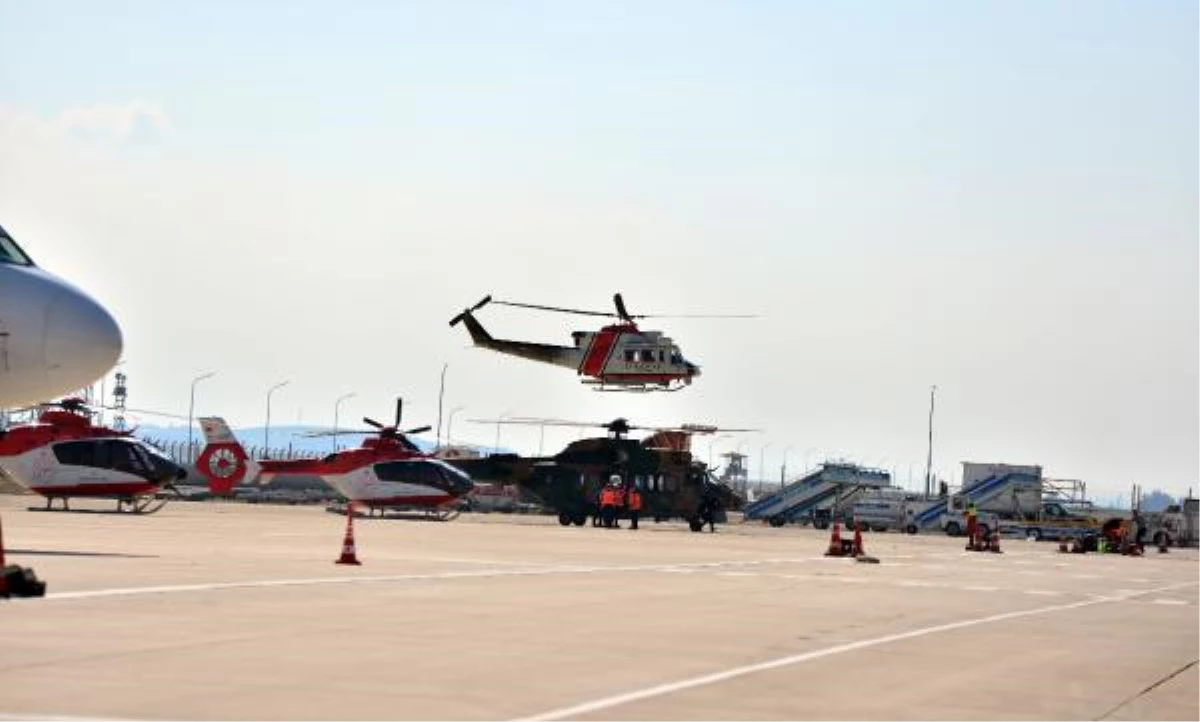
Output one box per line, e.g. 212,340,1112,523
196,401,474,521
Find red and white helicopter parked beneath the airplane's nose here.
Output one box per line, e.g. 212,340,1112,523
0,398,187,513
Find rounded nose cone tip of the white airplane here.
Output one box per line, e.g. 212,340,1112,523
44,288,122,389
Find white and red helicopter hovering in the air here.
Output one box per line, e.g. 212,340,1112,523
450,294,752,391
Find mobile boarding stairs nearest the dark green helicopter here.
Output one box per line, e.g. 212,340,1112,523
744,463,892,527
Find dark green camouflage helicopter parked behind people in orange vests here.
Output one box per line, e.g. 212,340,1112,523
445,419,756,531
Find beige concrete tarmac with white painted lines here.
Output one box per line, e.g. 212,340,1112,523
0,497,1200,722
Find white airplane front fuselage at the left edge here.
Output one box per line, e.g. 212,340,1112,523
0,228,122,409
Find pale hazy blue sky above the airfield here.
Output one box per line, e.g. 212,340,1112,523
0,1,1200,495
